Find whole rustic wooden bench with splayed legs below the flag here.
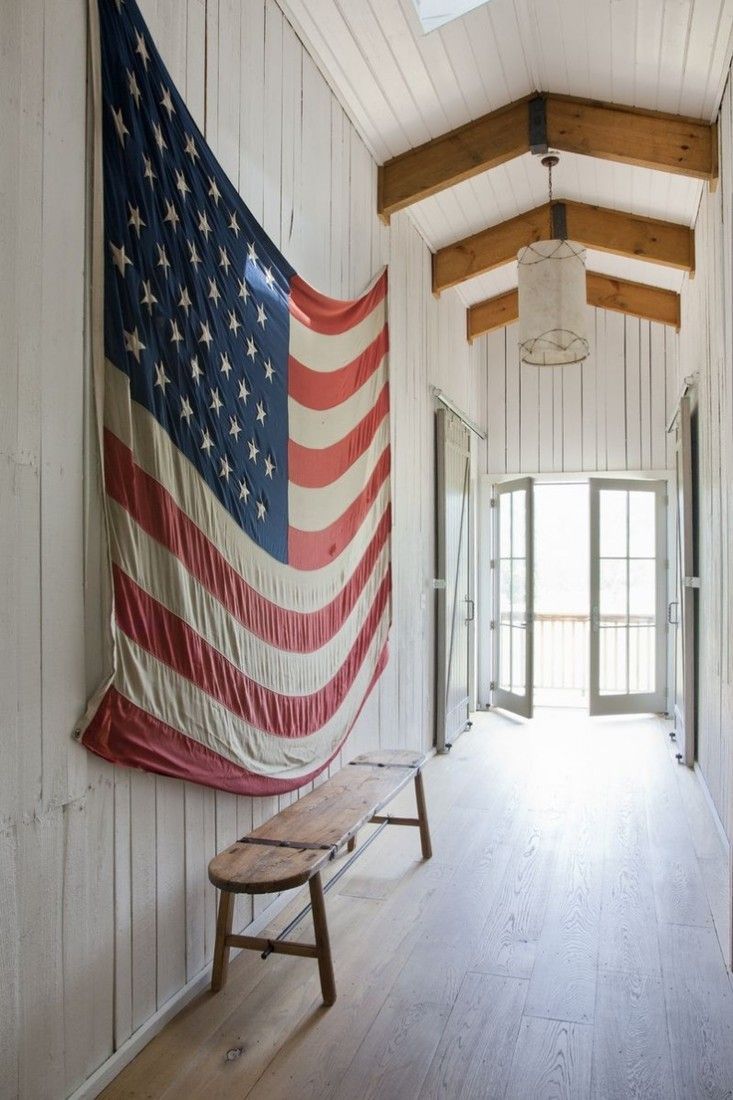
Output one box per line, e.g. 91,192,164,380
209,749,433,1004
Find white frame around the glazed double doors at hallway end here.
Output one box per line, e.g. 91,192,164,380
475,469,676,715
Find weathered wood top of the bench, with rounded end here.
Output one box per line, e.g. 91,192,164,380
209,749,425,893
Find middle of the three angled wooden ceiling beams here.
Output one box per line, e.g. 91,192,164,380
433,202,694,294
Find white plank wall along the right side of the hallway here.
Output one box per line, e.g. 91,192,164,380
678,73,733,837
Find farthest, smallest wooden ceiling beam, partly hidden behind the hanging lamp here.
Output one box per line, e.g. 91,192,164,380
466,272,680,343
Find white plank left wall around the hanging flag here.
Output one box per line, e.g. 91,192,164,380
0,0,486,1098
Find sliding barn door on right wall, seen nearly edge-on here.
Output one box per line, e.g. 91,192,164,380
669,395,699,768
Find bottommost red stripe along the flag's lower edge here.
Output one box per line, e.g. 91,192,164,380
81,645,387,795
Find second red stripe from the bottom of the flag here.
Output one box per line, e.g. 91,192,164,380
112,565,390,737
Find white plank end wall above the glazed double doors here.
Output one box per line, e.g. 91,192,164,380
475,309,678,474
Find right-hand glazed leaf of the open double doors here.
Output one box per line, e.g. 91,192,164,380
590,477,667,715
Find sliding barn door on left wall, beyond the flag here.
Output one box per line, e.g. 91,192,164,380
436,409,473,752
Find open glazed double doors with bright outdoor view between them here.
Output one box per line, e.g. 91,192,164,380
490,477,668,717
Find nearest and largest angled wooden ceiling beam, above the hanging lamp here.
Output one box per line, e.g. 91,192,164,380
378,95,718,221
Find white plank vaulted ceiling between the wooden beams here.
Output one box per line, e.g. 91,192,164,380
278,0,733,325
